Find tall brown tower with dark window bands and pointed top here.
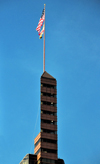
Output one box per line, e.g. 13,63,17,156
20,71,64,164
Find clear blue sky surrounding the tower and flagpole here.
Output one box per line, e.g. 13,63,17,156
0,0,100,164
